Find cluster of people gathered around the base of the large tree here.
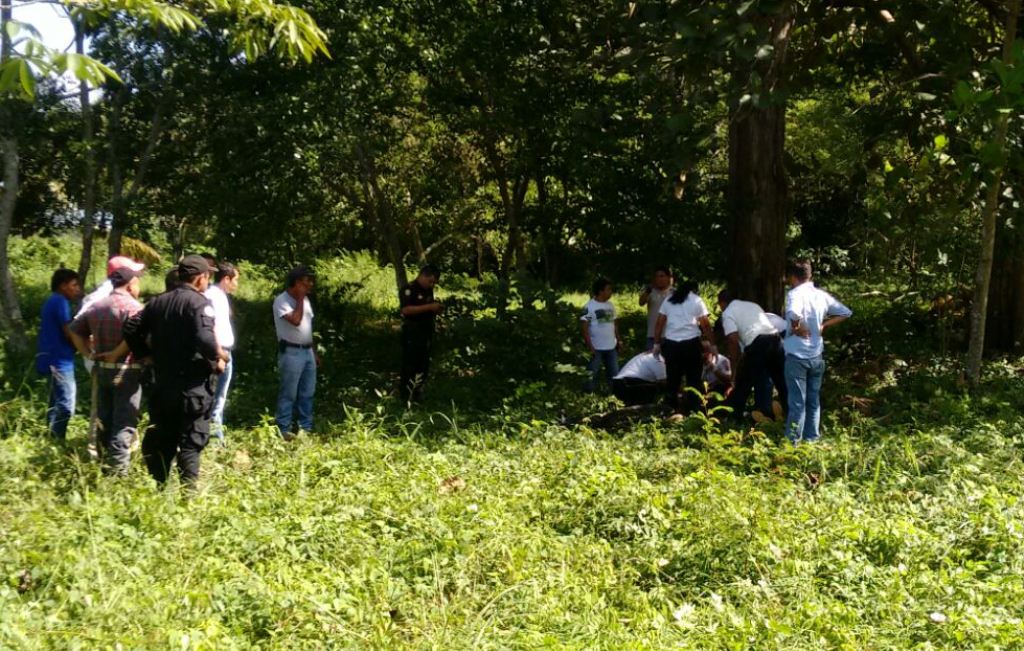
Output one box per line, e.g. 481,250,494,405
581,261,852,443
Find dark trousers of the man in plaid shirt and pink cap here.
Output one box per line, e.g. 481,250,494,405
93,368,142,475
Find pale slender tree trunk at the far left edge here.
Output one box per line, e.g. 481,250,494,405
0,2,28,351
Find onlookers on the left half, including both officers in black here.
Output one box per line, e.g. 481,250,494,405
36,255,443,484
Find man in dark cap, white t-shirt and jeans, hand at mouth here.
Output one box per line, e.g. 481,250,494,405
273,266,317,440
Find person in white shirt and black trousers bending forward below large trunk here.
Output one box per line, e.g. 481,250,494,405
718,290,787,422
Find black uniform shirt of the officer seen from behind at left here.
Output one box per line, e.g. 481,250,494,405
124,286,217,387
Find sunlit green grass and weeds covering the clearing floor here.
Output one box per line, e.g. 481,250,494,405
0,236,1024,649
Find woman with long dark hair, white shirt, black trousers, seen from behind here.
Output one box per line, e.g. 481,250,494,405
652,283,711,414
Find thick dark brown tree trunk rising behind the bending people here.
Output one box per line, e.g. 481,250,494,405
727,5,794,311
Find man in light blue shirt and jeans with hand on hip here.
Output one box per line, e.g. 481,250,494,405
782,262,853,444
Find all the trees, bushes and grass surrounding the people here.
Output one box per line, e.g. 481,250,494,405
0,0,1024,649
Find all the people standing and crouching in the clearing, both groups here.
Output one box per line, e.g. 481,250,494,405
36,255,851,483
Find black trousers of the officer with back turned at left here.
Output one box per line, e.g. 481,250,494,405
142,380,213,484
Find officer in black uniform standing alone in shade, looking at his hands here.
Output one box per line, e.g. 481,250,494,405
398,264,444,402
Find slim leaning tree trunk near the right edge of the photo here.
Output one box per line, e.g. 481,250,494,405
967,0,1021,387
